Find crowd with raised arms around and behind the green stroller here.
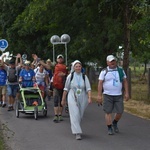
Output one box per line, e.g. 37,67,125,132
0,54,53,111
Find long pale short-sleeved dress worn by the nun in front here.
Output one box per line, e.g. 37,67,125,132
64,72,91,134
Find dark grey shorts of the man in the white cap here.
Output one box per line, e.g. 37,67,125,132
103,94,124,114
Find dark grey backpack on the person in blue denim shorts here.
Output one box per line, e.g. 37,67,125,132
7,68,18,82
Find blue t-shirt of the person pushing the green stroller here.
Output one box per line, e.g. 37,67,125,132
19,69,35,87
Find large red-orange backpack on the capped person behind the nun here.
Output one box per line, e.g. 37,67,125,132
53,64,67,89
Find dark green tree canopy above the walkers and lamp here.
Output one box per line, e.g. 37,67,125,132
0,0,150,69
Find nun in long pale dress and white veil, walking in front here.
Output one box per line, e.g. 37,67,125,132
62,60,92,140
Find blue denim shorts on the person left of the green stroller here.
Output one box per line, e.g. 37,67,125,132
7,84,19,98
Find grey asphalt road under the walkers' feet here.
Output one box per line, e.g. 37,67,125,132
0,98,150,150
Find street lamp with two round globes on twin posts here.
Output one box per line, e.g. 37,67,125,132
50,34,70,65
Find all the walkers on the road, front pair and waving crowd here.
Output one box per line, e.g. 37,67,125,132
0,54,129,140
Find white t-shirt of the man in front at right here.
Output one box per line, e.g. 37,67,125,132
98,67,126,95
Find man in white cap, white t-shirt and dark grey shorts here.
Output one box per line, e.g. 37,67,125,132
98,55,129,135
